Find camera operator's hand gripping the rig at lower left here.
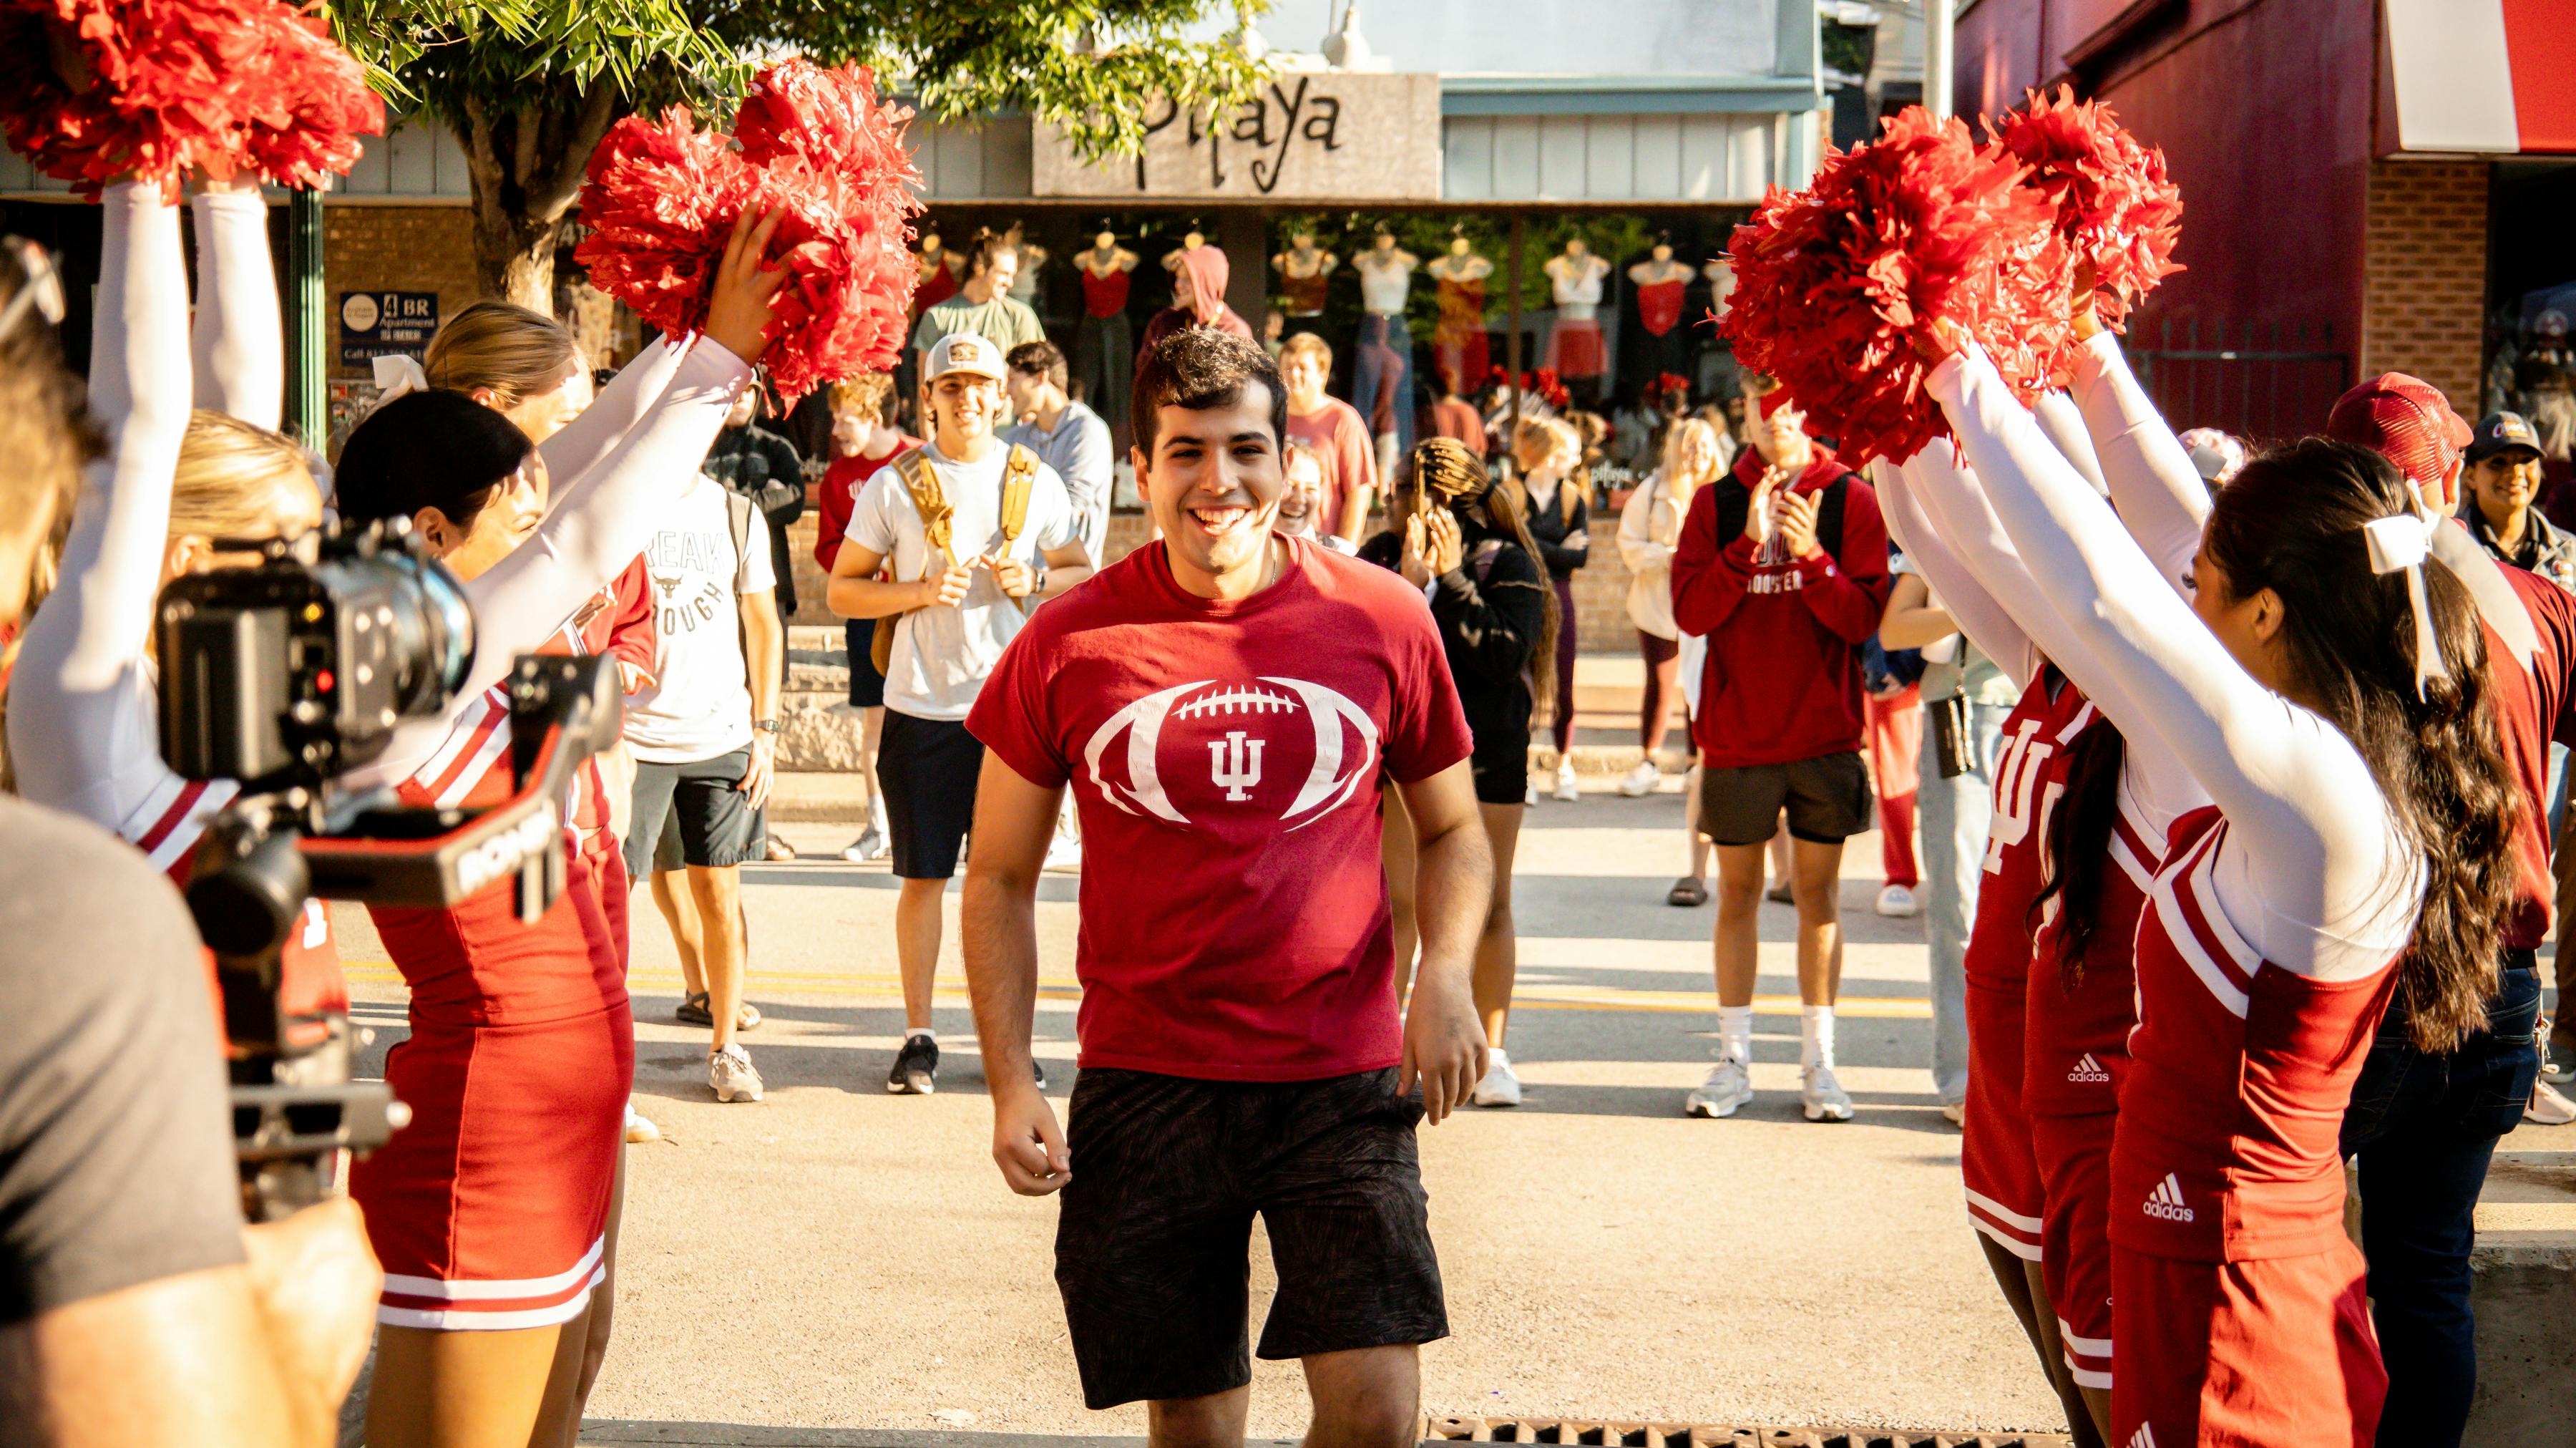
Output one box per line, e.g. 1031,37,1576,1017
242,1198,384,1440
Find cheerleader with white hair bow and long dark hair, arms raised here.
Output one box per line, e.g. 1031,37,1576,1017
1929,329,2519,1448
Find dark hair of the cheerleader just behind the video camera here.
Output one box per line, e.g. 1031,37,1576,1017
332,389,536,528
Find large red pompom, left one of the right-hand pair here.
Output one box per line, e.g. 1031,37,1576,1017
1718,106,2069,467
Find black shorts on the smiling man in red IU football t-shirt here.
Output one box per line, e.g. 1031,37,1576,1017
1056,1066,1448,1409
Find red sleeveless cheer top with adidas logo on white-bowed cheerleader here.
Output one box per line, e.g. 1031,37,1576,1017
2109,807,2396,1263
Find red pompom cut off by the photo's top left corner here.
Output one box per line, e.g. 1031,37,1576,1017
0,0,384,196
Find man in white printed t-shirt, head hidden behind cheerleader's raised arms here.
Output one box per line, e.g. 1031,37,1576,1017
626,474,786,1100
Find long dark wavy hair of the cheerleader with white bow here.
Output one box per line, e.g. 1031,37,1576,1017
2202,438,2522,1051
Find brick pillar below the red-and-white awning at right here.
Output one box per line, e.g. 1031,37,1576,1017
2360,160,2489,417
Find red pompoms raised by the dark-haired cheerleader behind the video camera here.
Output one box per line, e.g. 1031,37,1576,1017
575,59,919,402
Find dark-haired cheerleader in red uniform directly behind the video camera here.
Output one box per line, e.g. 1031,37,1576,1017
338,216,783,1448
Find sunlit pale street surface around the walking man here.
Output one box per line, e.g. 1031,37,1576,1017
338,781,2064,1440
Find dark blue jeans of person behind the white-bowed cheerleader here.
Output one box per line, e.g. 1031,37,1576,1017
2344,951,2540,1448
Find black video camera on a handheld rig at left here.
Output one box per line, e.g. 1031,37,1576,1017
155,520,621,1221
